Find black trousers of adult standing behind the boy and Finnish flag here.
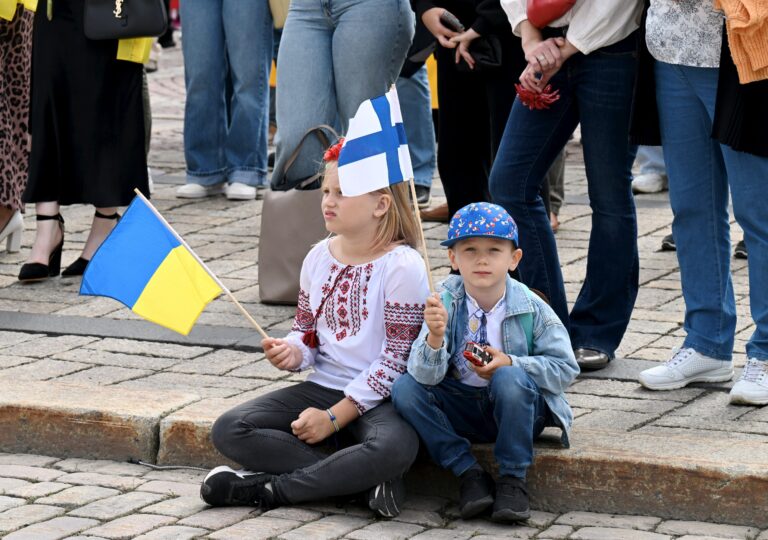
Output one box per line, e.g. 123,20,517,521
435,31,526,215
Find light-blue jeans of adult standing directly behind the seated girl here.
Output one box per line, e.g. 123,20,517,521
272,0,415,188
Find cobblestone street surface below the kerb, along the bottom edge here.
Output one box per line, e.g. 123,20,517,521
0,454,768,540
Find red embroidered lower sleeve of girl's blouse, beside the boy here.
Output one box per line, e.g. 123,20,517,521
366,302,424,398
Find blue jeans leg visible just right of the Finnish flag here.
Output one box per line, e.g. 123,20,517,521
397,65,437,187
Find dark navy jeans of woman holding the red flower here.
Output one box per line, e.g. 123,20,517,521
490,34,639,357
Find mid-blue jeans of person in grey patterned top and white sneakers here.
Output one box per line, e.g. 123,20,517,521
655,62,768,360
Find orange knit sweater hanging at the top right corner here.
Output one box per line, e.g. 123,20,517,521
714,0,768,84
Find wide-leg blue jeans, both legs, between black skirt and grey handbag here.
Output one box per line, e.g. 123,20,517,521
181,0,273,186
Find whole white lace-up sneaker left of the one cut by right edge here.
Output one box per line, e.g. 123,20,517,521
639,347,733,390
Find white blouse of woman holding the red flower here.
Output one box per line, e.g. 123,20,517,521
501,0,643,54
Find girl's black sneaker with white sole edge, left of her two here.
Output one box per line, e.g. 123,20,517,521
200,465,275,509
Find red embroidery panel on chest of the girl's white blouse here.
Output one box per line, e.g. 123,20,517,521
323,263,373,341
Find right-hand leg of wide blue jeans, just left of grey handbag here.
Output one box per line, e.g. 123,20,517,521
220,0,273,186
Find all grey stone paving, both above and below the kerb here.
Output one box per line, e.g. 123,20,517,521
0,37,768,540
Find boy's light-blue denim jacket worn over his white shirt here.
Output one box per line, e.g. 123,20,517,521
408,275,579,447
